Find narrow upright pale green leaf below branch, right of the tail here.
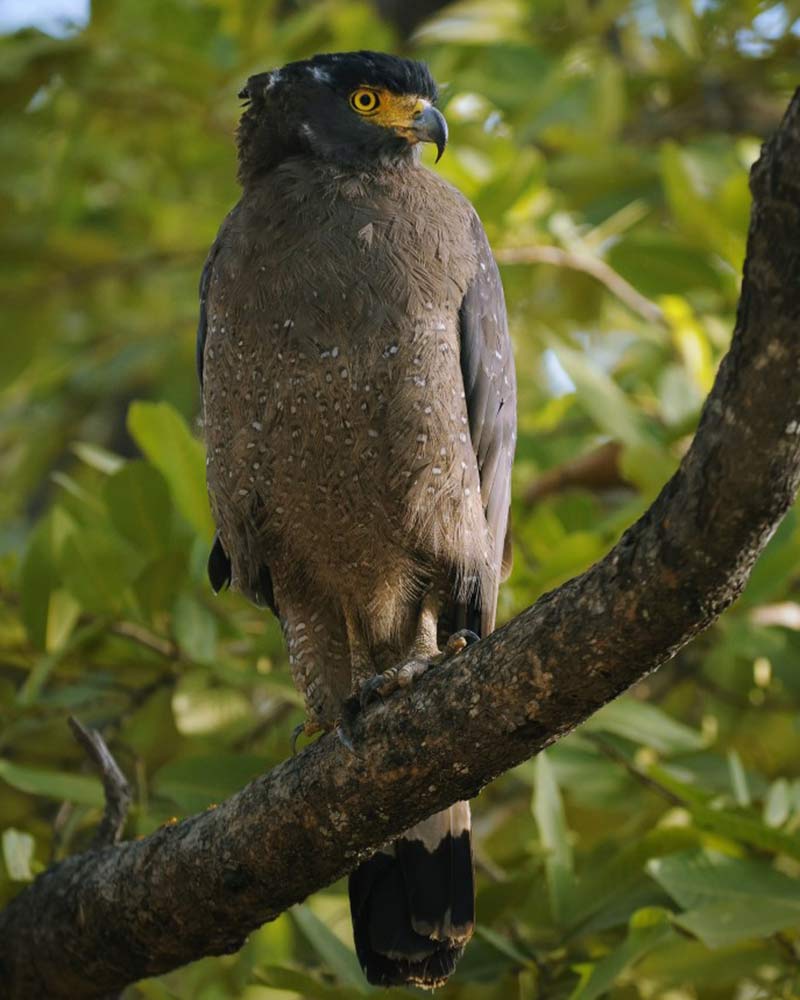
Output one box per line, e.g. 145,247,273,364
533,751,575,923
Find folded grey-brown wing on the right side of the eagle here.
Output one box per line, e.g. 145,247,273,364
456,216,517,636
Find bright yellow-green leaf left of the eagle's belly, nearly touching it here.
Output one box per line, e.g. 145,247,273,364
128,402,214,541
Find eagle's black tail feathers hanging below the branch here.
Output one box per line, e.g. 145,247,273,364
350,802,475,989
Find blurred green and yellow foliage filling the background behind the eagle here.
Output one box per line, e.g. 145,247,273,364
0,0,800,1000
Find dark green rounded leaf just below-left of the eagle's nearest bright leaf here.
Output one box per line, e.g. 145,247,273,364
103,462,172,554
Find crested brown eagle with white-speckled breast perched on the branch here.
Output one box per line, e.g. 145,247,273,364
197,52,516,988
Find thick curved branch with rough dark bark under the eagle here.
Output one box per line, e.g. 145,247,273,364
0,91,800,998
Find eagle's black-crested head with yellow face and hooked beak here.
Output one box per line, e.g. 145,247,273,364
237,52,447,183
